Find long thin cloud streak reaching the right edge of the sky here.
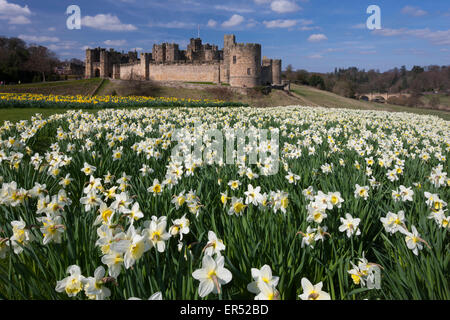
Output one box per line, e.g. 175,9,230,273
373,28,450,45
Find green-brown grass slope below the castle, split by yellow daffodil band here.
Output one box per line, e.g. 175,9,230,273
0,79,450,123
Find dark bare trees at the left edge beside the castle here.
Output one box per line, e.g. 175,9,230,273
0,37,82,84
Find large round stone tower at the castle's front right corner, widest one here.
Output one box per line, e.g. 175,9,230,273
230,43,261,88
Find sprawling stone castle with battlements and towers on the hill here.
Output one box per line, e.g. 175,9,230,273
85,35,281,88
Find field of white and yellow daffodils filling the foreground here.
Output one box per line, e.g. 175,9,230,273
0,106,450,300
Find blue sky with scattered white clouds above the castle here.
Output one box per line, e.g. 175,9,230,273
0,0,450,72
